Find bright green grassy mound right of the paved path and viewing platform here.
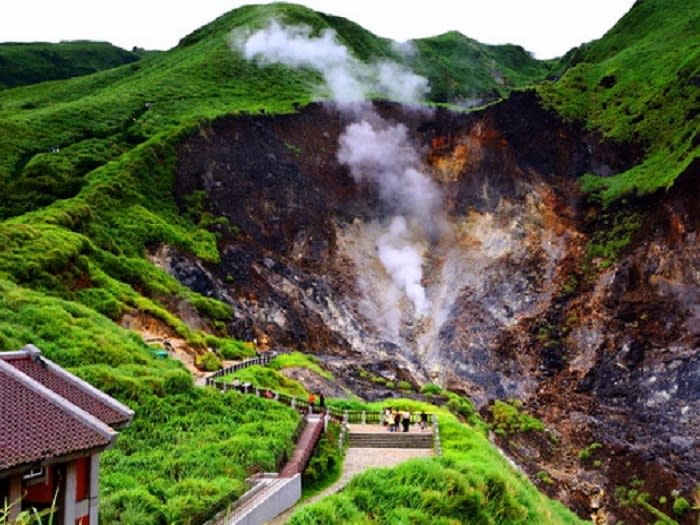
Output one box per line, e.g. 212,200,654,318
290,399,582,525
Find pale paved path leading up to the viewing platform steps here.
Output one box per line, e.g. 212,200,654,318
267,442,433,525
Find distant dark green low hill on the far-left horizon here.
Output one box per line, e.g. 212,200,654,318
0,40,141,89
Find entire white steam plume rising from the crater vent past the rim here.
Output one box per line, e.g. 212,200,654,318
231,21,442,328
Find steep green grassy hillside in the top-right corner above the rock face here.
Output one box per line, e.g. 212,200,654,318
539,0,700,202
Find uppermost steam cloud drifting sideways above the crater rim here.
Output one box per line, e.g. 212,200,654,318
231,20,428,104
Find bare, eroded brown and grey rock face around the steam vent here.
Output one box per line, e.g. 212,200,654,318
172,93,700,523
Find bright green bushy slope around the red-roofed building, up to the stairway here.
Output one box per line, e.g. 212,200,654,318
0,280,298,525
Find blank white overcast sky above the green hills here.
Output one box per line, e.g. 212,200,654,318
0,0,634,59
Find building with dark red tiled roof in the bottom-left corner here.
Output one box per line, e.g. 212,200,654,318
0,345,134,525
